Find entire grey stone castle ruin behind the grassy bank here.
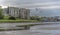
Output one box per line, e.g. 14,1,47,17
3,7,30,19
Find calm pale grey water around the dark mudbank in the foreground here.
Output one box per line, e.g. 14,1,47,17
0,23,60,35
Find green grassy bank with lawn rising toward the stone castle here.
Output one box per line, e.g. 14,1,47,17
0,16,38,23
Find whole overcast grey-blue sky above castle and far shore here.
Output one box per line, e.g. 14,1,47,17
0,0,60,16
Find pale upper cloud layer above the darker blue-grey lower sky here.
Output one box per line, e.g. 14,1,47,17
0,0,60,8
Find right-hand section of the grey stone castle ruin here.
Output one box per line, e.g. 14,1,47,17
19,8,30,19
